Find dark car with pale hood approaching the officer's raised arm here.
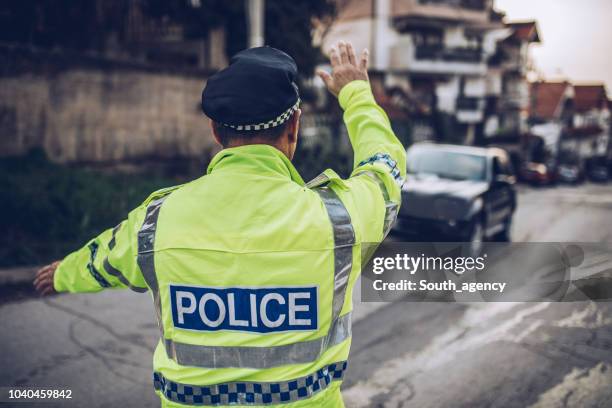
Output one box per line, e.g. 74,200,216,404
394,143,516,253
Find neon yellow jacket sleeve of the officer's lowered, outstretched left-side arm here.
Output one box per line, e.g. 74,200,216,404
53,188,174,292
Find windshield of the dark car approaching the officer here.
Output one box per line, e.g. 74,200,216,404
408,149,486,181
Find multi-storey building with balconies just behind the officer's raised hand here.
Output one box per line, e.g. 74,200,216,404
321,0,539,144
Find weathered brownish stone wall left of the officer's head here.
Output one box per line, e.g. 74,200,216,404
0,47,215,163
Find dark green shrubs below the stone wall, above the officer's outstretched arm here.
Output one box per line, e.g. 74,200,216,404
0,150,182,267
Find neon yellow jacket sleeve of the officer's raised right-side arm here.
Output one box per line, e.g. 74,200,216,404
313,81,406,243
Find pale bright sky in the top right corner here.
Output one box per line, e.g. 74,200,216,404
495,0,612,96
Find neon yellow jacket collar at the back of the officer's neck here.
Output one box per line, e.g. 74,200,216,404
206,144,305,186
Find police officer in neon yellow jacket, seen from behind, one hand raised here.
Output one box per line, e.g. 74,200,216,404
35,42,406,407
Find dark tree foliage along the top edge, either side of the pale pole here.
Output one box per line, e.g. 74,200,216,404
0,0,334,75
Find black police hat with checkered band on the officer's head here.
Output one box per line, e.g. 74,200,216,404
202,47,300,131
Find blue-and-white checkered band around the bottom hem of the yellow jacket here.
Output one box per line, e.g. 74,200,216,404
153,361,347,406
